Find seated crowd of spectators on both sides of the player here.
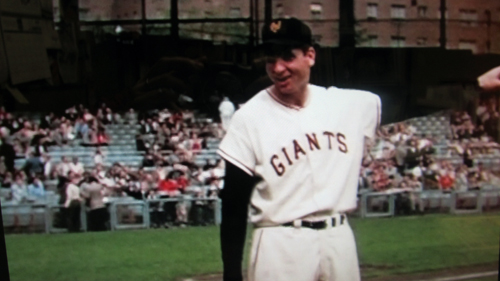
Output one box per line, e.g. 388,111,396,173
4,99,500,231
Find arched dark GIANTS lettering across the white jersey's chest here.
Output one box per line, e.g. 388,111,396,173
270,131,348,177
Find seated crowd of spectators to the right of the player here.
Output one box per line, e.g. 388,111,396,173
359,111,500,209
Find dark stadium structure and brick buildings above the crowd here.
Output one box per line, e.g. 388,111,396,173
0,0,500,123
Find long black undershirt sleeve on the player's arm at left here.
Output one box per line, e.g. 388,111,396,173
220,161,257,281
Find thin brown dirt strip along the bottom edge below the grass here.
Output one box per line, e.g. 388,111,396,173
179,263,498,281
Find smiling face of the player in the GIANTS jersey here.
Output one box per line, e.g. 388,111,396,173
266,47,316,95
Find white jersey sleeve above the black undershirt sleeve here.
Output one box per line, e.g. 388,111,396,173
217,111,256,176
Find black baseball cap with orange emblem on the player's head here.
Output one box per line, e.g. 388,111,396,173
262,18,313,47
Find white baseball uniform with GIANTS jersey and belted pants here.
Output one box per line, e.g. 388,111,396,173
218,84,381,281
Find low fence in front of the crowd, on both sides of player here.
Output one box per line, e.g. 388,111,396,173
2,188,500,233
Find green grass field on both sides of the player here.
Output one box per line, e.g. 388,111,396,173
5,214,500,281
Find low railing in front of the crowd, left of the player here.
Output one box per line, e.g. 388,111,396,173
2,198,221,233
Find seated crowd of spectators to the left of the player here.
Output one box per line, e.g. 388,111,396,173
0,105,224,231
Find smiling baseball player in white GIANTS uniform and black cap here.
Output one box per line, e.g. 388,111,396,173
218,18,381,281
